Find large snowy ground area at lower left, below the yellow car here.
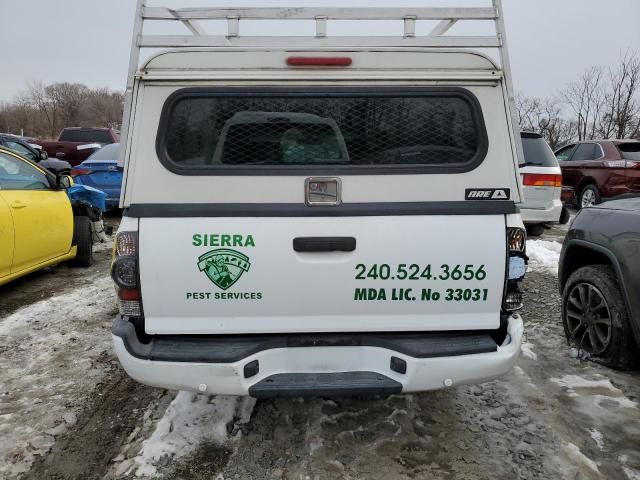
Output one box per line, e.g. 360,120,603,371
0,277,115,478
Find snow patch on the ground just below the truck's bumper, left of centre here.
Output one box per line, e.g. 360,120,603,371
134,391,255,478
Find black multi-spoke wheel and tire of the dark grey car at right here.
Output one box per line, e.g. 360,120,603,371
562,265,635,370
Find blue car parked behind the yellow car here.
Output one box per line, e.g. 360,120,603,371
71,143,122,209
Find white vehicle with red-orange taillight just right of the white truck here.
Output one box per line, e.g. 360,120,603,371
520,132,569,236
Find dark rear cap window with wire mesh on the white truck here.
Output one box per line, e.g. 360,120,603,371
160,89,486,169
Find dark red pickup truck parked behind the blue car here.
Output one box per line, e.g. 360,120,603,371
39,127,120,166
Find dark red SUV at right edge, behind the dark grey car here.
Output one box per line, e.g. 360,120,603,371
556,140,640,208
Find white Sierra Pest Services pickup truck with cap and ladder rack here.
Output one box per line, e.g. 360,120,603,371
112,0,526,398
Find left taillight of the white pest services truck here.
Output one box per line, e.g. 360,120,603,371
111,232,142,317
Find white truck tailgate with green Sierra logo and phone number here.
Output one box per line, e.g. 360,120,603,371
139,215,506,334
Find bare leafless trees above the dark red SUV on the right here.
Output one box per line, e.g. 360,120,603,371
516,51,640,150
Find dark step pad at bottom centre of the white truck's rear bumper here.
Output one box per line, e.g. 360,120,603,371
249,372,402,398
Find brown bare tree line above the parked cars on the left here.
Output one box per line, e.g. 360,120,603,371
0,82,124,139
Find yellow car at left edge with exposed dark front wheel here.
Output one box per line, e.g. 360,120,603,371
0,148,93,285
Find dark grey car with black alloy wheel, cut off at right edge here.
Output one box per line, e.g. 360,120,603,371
558,195,640,369
